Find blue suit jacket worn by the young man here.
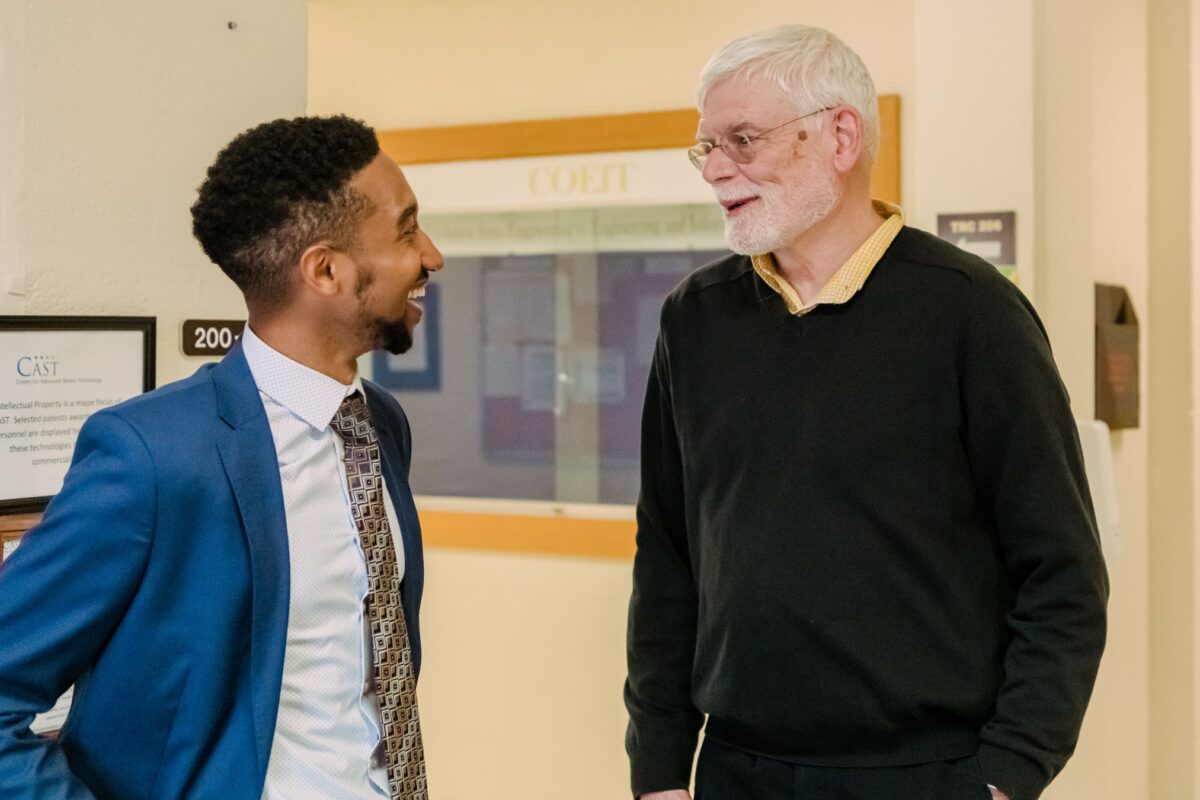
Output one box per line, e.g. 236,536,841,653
0,345,425,800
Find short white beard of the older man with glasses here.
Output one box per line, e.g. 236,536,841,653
714,169,842,255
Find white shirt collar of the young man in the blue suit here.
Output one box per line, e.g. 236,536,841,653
241,324,362,431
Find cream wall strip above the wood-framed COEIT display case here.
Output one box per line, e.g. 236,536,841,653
308,0,914,212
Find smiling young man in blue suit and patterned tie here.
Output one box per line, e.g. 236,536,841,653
0,118,442,800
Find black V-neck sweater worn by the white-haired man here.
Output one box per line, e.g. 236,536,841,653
625,228,1108,800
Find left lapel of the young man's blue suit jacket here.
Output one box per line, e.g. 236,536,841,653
212,344,290,780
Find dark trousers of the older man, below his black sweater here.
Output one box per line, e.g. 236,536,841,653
695,739,991,800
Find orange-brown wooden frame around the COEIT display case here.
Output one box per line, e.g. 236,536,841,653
378,101,900,559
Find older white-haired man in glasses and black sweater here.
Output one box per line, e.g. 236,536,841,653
625,25,1108,800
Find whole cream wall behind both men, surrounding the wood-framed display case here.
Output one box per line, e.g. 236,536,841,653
310,0,1180,800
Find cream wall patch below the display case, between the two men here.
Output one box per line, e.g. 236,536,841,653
420,549,630,800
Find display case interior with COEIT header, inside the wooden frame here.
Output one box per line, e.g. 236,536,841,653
370,160,727,504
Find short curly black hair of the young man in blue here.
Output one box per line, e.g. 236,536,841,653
192,115,379,306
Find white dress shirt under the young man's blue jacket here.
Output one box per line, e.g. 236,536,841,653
242,325,404,800
